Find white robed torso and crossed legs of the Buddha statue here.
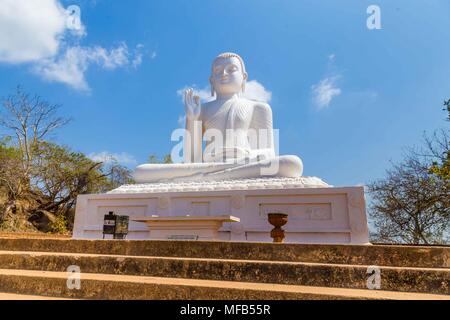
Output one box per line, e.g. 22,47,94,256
134,98,303,183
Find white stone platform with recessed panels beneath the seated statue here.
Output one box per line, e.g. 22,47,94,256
73,177,369,244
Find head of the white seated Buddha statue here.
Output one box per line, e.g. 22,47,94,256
209,52,248,96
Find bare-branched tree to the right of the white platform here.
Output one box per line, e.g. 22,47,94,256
369,100,450,244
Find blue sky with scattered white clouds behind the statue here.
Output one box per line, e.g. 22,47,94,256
0,0,450,186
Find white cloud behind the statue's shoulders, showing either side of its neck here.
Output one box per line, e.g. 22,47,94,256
177,80,272,102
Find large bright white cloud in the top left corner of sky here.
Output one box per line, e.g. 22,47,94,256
0,0,143,91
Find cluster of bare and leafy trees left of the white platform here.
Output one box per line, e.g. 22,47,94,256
0,88,132,232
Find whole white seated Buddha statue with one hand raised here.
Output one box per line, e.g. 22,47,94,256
134,53,303,183
